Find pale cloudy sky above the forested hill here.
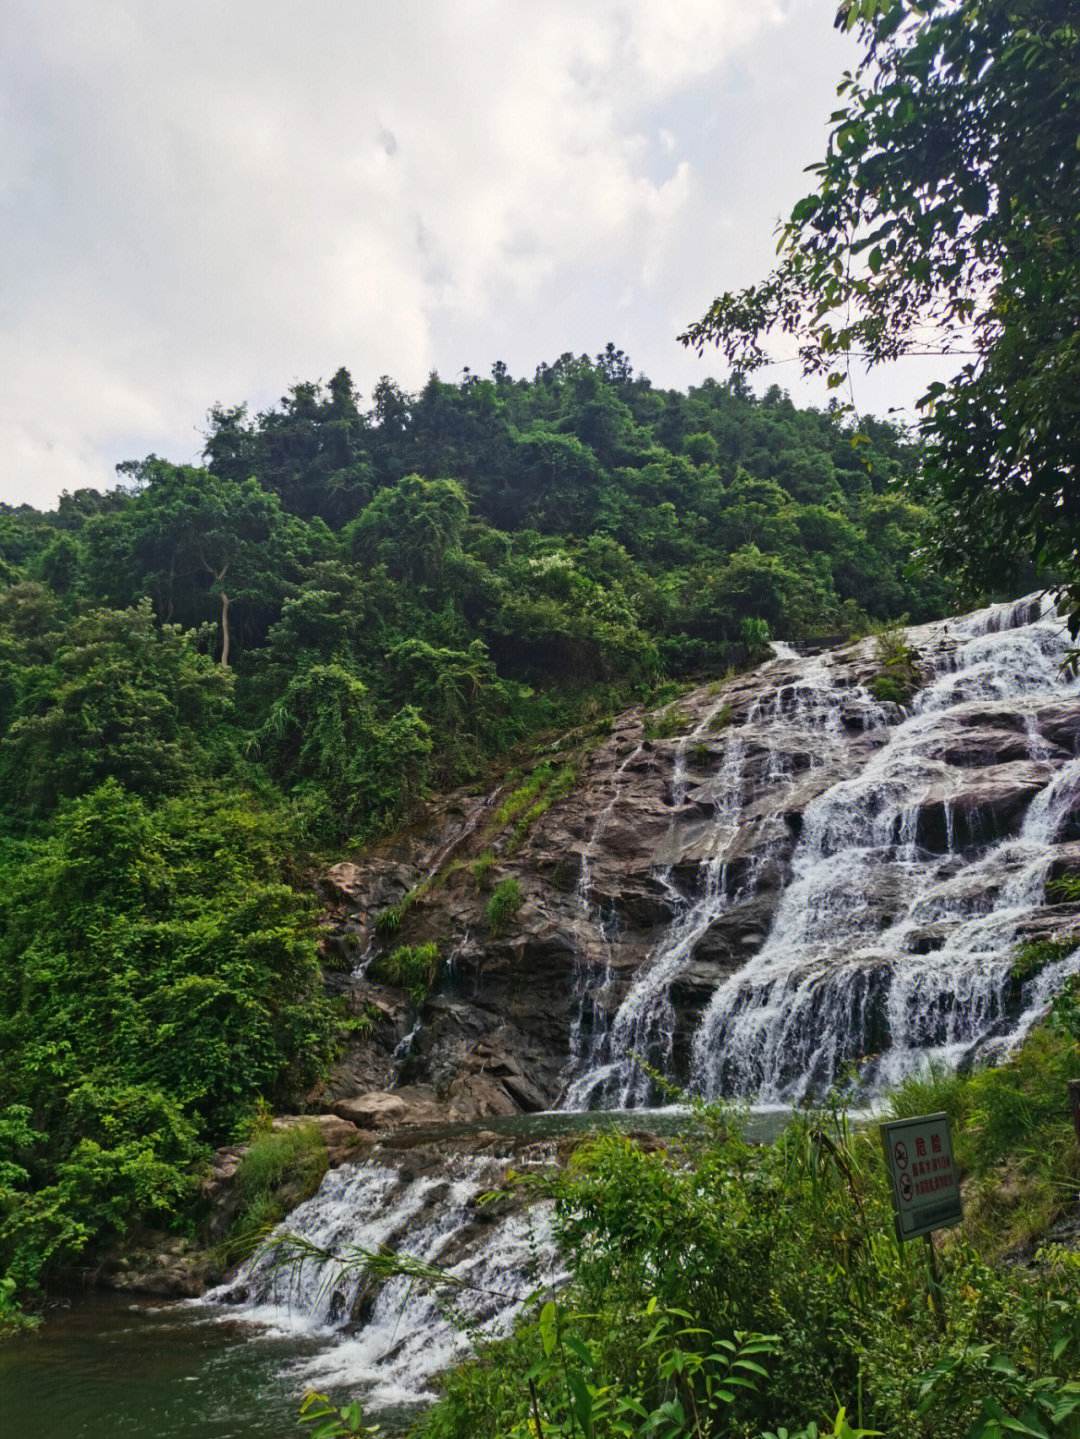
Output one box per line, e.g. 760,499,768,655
0,0,943,507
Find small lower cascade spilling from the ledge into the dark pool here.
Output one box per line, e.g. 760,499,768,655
197,1154,561,1407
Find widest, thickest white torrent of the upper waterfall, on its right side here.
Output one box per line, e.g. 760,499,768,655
692,600,1080,1102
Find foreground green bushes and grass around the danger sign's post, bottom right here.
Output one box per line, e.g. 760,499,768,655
418,1055,1080,1439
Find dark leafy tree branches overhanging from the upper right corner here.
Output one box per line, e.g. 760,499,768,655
683,0,1080,633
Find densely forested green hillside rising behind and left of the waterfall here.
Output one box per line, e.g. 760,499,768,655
0,347,945,1286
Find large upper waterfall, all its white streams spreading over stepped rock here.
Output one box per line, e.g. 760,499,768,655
564,596,1080,1108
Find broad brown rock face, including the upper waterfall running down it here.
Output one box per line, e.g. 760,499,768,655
311,589,1080,1130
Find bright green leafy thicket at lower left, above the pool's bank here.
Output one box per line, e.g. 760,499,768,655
0,780,332,1285
